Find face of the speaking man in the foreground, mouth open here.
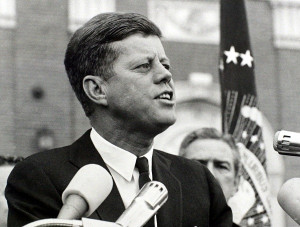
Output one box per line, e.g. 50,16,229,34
106,34,176,132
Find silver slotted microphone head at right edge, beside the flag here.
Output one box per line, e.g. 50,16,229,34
273,130,300,156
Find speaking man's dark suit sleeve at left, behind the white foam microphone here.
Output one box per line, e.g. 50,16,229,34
5,160,62,227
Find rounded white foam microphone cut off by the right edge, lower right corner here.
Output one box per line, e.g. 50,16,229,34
277,178,300,225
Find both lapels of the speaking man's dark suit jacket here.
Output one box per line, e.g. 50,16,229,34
70,130,182,223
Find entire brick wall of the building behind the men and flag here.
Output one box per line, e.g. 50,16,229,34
0,0,300,224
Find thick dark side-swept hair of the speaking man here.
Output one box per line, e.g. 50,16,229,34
64,13,162,117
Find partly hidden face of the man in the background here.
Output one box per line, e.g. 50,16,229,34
186,139,237,201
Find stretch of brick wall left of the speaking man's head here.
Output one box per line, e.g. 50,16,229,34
0,0,73,156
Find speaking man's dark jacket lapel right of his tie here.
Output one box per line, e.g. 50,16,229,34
152,151,182,227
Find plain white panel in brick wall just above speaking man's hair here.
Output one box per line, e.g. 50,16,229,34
68,0,115,32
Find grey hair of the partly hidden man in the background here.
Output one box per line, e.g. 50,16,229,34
179,128,241,177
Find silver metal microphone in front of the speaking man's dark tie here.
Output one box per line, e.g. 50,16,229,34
116,181,168,227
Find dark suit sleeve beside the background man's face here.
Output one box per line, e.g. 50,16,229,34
204,168,233,227
